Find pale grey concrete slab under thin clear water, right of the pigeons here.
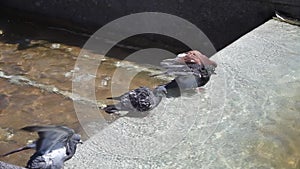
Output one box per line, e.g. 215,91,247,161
66,20,300,169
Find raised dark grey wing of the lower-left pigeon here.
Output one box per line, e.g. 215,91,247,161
22,126,75,155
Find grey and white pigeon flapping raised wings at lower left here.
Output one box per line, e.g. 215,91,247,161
1,126,82,169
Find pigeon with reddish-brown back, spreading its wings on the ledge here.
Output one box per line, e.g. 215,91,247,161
152,50,217,97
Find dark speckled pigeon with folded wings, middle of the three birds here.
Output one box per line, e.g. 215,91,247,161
102,86,167,115
